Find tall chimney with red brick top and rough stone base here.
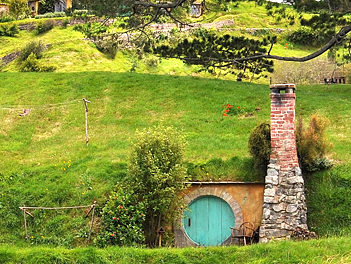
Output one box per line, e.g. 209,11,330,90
260,84,308,242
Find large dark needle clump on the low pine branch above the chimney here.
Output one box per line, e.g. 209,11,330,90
154,29,276,80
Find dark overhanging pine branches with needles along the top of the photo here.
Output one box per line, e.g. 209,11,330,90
76,0,351,78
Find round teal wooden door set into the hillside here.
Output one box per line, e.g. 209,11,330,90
183,196,235,246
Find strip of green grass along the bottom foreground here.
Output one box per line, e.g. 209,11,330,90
0,237,351,264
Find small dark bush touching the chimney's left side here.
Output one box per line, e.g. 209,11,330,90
248,122,271,176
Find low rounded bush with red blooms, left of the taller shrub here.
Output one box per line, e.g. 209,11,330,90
95,184,145,247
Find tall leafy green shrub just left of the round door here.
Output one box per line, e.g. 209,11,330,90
127,125,186,247
